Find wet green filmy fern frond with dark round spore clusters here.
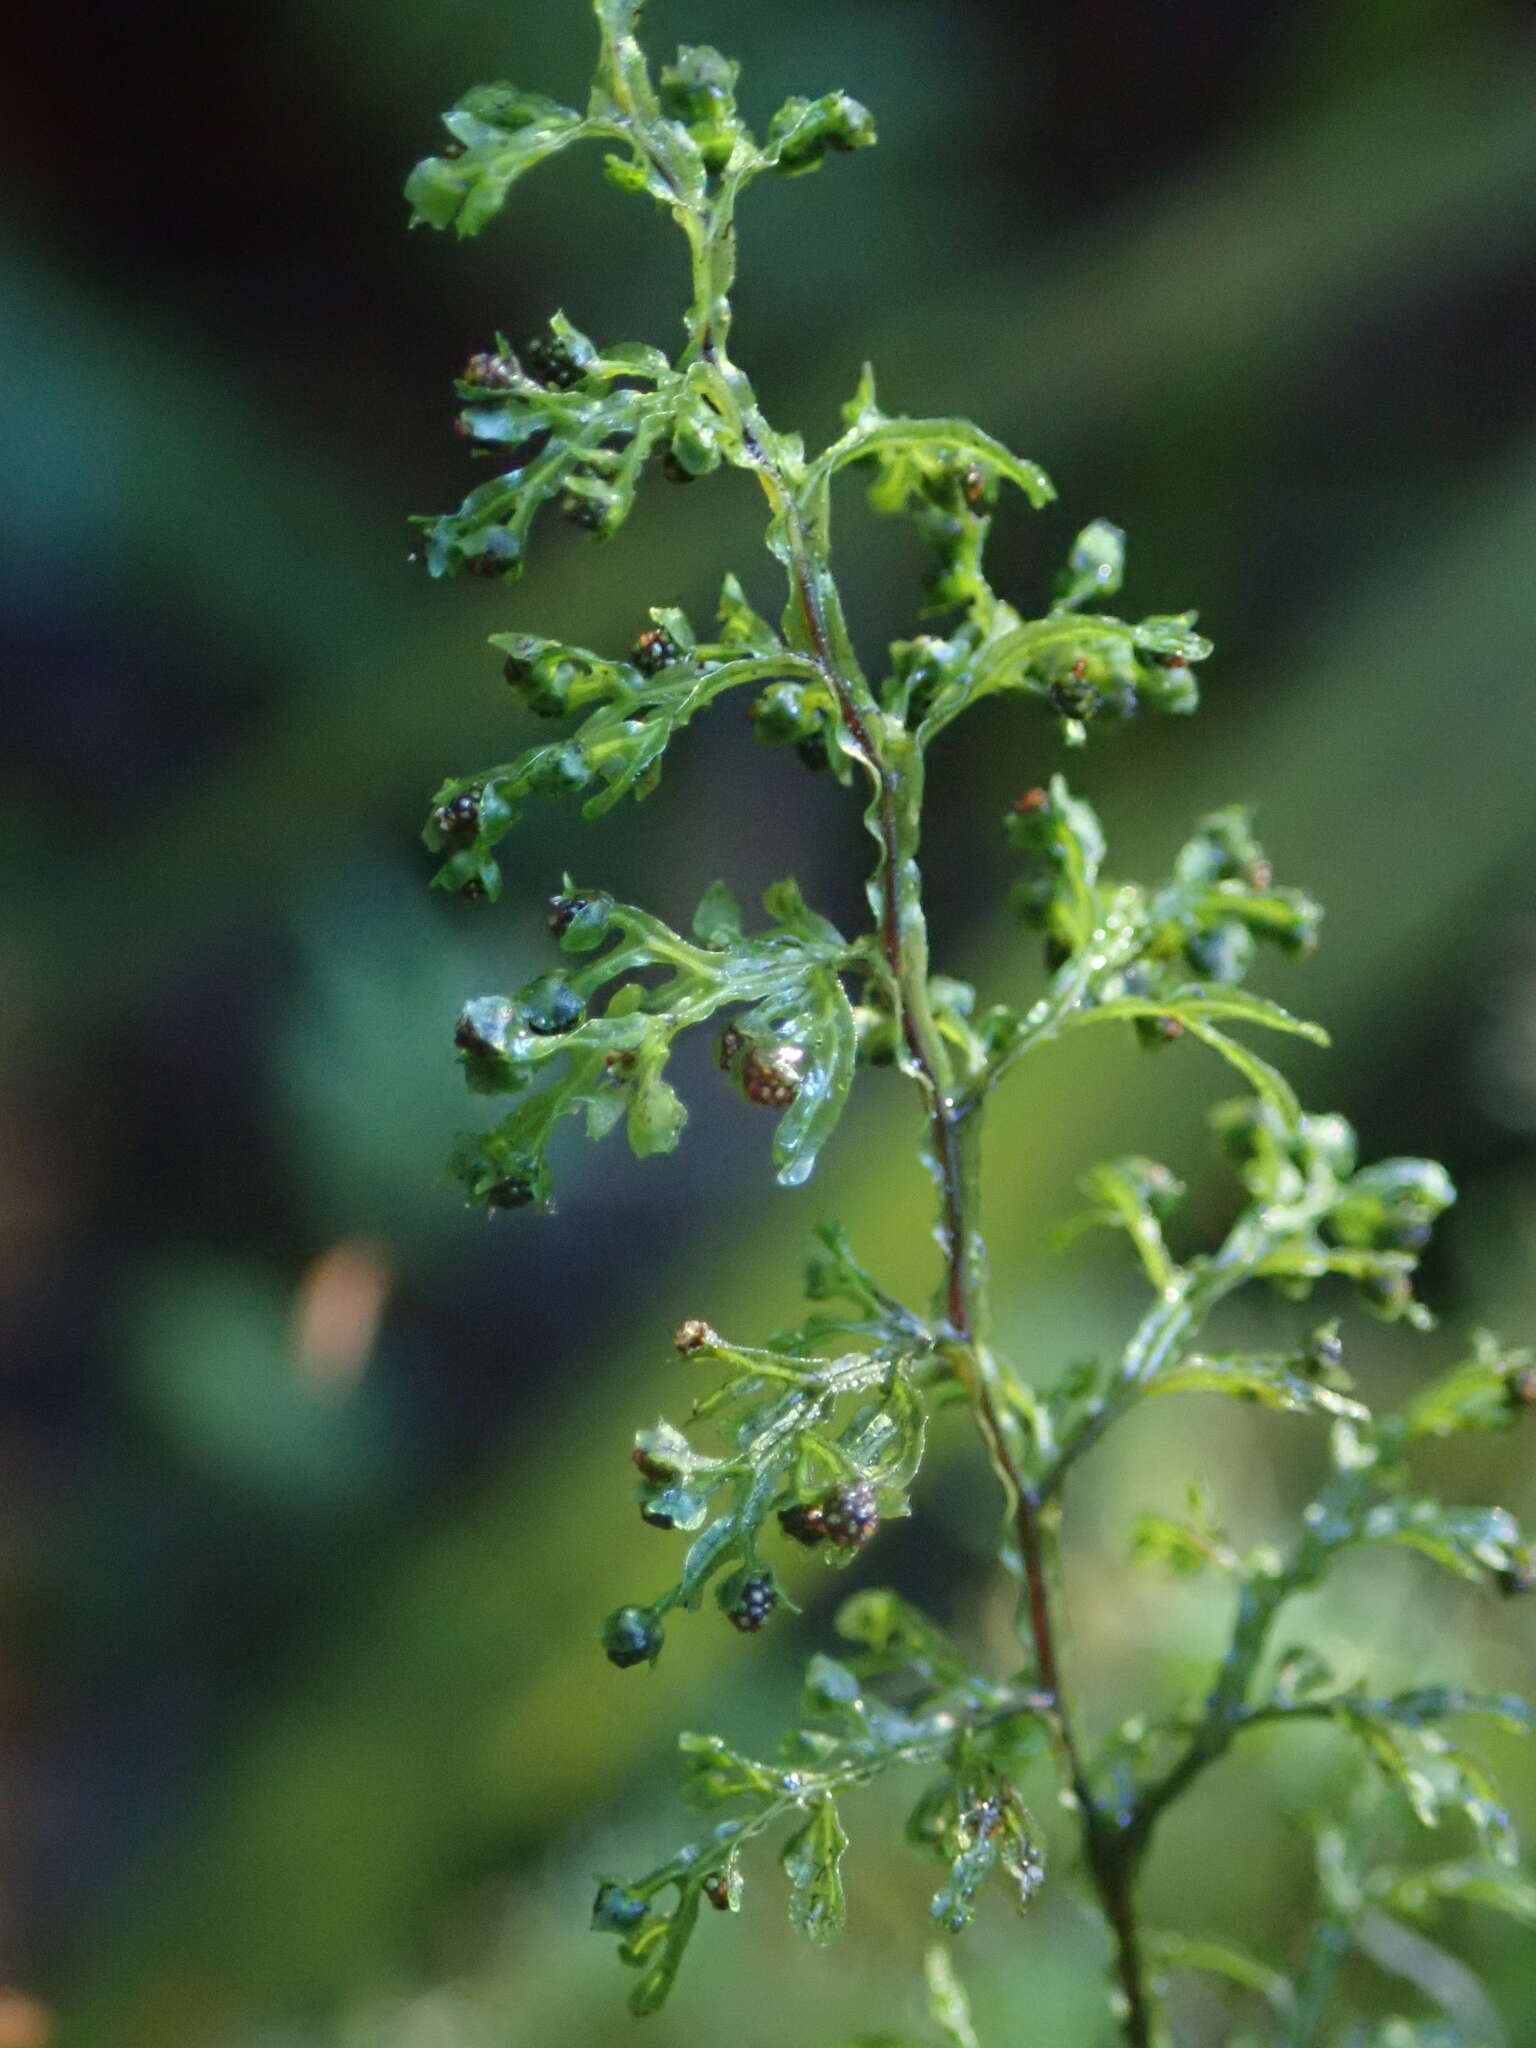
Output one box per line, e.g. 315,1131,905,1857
408,0,1536,2048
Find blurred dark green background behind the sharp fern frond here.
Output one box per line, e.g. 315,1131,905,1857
0,0,1536,2048
